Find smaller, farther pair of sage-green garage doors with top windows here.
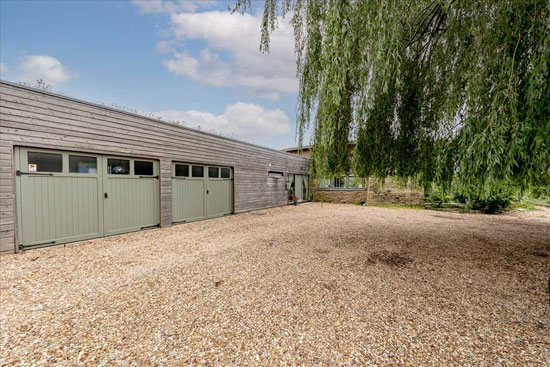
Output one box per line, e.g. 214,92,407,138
172,163,233,223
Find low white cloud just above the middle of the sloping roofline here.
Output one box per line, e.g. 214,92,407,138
155,102,290,143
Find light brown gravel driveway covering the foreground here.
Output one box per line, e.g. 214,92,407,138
0,204,550,366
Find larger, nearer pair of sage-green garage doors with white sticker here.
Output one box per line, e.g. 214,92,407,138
15,148,160,248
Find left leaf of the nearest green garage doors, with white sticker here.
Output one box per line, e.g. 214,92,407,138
16,148,103,247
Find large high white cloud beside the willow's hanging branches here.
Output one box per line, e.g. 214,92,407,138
164,11,298,100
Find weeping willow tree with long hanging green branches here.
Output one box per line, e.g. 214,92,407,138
234,0,550,198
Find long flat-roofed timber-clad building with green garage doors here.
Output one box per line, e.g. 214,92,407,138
0,81,309,251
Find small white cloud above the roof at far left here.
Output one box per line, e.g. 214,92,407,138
18,55,70,85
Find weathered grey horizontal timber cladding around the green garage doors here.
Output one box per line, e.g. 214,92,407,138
0,82,309,251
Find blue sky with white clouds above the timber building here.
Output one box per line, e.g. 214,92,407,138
0,0,307,149
